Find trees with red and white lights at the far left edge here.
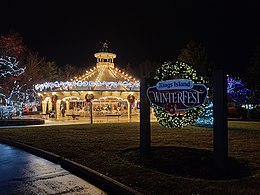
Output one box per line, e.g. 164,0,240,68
0,33,41,118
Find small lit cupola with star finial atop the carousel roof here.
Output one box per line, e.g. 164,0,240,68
94,42,116,69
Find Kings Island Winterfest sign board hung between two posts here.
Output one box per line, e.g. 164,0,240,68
147,79,208,114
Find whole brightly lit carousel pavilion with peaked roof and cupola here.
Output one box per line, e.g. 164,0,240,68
35,43,140,120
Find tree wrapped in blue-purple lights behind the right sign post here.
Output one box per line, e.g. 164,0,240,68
227,76,251,103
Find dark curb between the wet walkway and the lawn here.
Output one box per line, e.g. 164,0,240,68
0,138,141,195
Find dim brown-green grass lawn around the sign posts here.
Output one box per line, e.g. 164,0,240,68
0,121,260,195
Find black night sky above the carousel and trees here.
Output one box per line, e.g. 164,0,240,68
0,0,260,74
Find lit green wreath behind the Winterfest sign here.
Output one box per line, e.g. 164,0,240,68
152,61,204,128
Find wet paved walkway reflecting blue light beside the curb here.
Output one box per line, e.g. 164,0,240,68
0,144,106,195
